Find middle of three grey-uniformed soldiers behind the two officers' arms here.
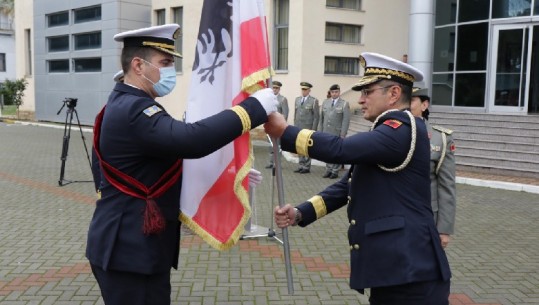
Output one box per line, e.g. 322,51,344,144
294,82,320,174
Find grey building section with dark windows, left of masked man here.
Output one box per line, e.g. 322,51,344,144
16,0,151,125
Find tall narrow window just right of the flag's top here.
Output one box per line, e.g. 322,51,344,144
273,0,290,70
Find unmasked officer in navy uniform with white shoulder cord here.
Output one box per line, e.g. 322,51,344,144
265,53,451,305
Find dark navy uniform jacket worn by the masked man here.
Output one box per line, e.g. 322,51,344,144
86,83,267,274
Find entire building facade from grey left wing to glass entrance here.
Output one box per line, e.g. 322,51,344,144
11,0,539,124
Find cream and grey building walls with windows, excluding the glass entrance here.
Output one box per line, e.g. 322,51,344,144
15,0,409,124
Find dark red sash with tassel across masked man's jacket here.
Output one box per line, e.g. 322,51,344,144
94,107,183,235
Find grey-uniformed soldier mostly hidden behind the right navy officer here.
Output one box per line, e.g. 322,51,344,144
410,88,457,248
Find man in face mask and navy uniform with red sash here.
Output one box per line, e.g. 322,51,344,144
86,24,278,305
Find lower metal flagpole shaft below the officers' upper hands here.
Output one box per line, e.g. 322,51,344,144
272,137,294,294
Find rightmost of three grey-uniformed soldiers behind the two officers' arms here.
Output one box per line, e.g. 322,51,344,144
318,85,350,179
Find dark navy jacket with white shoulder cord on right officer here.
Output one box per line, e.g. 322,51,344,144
281,111,451,292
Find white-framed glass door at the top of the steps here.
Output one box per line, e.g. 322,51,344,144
489,25,538,113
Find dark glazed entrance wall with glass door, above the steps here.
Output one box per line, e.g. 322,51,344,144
429,0,539,115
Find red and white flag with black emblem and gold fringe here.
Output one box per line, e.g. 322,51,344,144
180,0,271,250
